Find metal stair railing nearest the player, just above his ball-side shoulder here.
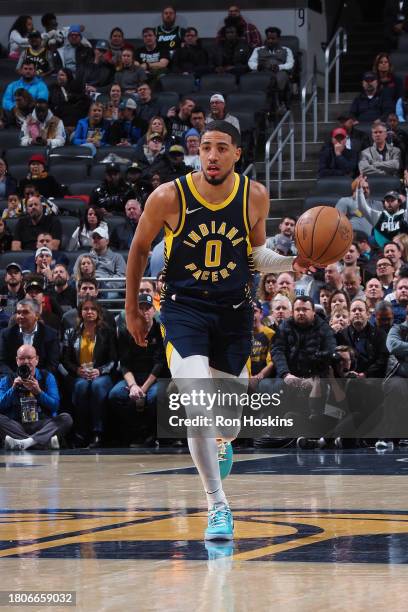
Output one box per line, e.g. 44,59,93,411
265,110,295,198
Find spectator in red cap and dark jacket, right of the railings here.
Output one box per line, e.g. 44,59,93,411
318,127,358,178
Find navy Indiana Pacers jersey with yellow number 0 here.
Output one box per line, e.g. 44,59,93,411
164,173,253,301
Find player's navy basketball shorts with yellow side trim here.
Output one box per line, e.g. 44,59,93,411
160,294,253,376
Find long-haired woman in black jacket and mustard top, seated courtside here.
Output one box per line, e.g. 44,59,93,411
61,298,117,448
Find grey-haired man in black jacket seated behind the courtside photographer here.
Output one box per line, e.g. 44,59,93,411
0,298,60,376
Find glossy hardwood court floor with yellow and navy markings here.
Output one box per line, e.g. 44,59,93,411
0,450,408,612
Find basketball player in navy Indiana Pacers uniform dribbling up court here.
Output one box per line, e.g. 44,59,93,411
126,121,309,540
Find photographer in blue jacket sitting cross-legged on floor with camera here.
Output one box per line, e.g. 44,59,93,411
0,344,72,451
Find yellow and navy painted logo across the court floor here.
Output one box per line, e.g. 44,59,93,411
0,508,408,563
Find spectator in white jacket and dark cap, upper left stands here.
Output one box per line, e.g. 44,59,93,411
20,98,66,148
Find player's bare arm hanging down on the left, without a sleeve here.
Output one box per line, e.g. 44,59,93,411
125,183,179,346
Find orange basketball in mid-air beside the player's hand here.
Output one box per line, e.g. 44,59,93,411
295,206,353,266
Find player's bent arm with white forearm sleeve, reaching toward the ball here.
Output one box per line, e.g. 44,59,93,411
249,181,312,273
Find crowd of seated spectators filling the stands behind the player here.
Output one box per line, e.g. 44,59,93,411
0,6,408,449
